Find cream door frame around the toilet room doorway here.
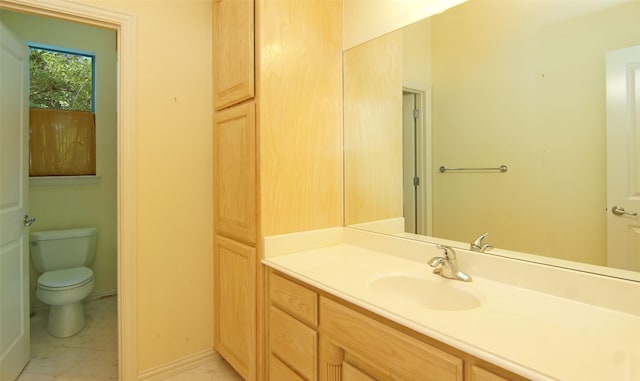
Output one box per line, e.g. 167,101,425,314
0,0,138,380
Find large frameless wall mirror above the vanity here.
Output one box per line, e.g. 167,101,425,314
344,0,640,280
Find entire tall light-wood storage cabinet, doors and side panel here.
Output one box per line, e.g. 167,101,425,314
212,0,342,381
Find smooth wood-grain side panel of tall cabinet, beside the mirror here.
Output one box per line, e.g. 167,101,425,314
256,1,342,236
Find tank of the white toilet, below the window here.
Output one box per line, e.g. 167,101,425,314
29,227,96,273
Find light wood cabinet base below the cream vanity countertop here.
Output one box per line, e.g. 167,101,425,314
266,269,526,381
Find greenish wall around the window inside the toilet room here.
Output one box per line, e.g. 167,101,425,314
0,11,117,305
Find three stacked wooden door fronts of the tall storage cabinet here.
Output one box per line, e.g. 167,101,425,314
212,0,259,380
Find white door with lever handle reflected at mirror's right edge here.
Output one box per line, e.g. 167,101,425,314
607,46,640,271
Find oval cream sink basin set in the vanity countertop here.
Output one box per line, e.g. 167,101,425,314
369,273,480,311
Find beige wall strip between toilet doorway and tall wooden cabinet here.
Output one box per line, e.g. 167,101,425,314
71,0,213,371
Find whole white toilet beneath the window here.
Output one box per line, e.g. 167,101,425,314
29,227,96,337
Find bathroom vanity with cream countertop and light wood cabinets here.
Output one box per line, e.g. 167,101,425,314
263,228,640,381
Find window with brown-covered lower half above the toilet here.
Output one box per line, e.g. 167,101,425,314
29,45,96,177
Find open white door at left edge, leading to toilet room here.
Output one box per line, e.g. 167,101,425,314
0,23,30,380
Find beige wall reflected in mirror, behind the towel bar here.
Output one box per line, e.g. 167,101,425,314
432,1,640,265
